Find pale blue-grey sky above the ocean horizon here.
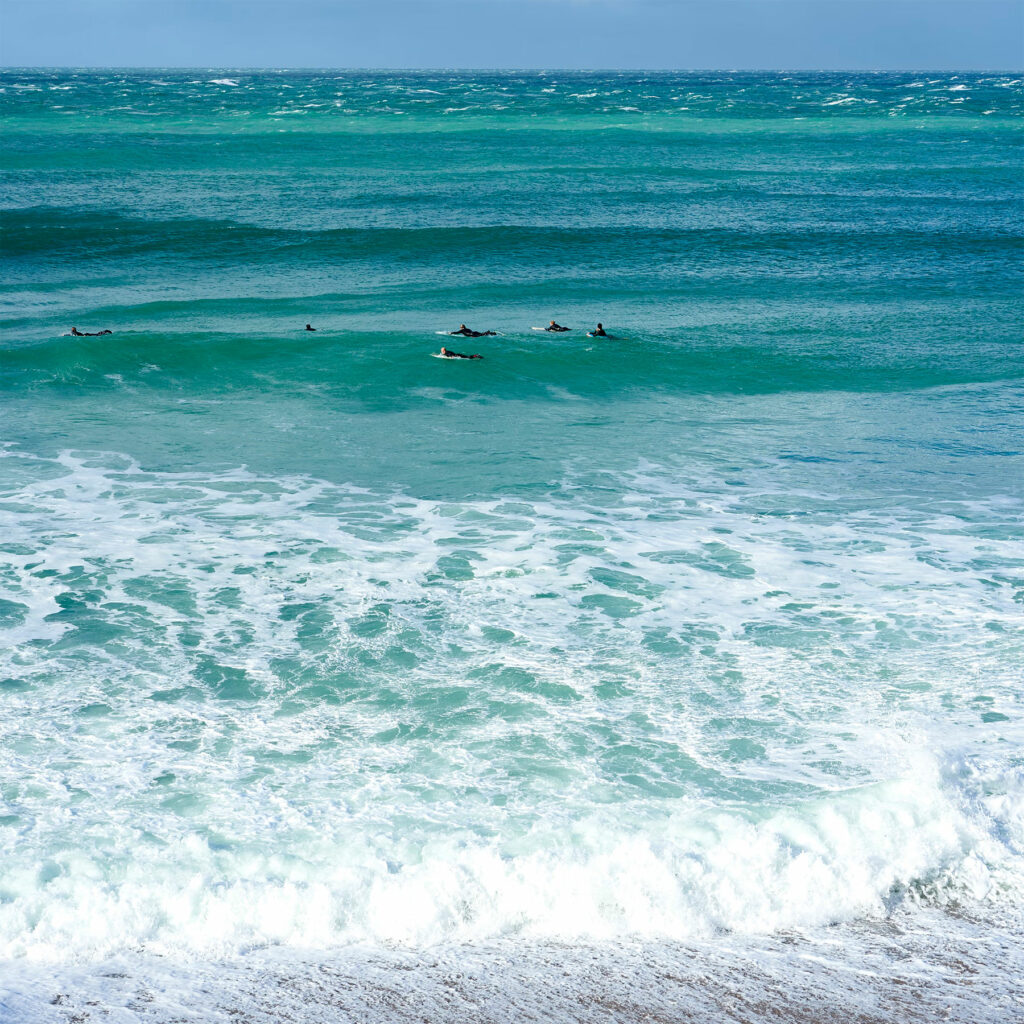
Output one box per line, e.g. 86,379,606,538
0,0,1024,71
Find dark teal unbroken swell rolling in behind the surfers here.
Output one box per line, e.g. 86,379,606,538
0,207,1024,281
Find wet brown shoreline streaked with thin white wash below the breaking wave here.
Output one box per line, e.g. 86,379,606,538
0,907,1024,1024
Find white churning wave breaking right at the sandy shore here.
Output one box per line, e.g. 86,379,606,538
0,753,1024,962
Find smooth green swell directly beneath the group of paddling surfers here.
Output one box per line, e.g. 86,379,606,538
0,330,1024,407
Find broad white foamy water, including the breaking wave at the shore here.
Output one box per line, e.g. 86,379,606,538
0,451,1024,961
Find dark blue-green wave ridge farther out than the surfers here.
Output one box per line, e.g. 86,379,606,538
0,207,1020,262
